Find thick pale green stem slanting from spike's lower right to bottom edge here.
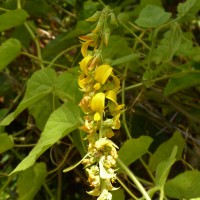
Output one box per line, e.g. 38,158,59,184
117,158,151,200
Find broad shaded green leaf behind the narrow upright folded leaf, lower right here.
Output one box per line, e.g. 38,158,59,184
149,131,185,171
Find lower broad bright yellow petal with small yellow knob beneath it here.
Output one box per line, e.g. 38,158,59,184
90,92,105,121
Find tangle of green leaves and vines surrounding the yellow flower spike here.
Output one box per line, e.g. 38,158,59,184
0,0,200,200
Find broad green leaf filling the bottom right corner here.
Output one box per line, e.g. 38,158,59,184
165,171,200,199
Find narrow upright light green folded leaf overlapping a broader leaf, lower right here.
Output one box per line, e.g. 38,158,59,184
155,146,178,187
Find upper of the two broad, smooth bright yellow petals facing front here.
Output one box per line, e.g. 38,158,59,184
94,64,113,84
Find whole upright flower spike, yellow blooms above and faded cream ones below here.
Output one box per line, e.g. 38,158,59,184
78,7,124,200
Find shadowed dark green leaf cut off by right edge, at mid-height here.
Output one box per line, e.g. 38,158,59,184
164,72,200,96
